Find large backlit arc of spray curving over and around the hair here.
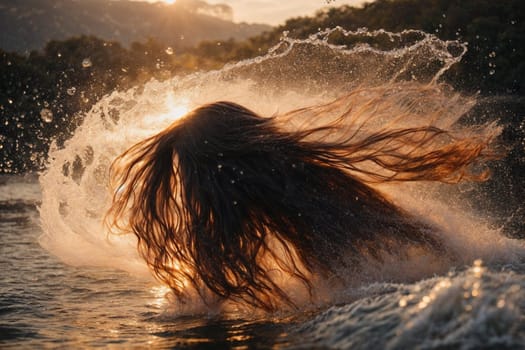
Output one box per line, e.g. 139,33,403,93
40,28,522,288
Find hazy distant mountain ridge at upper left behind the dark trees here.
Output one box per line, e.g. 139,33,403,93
0,0,271,52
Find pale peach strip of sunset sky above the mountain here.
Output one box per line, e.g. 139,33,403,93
151,0,371,25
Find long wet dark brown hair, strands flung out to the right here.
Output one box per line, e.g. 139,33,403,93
107,91,494,311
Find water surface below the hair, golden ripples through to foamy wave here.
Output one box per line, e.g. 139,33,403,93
0,178,525,349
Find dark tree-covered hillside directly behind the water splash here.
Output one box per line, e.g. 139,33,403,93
0,0,525,173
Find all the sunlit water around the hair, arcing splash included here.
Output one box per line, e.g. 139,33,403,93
0,29,525,349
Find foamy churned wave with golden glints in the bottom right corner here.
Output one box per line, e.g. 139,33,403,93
293,260,525,349
